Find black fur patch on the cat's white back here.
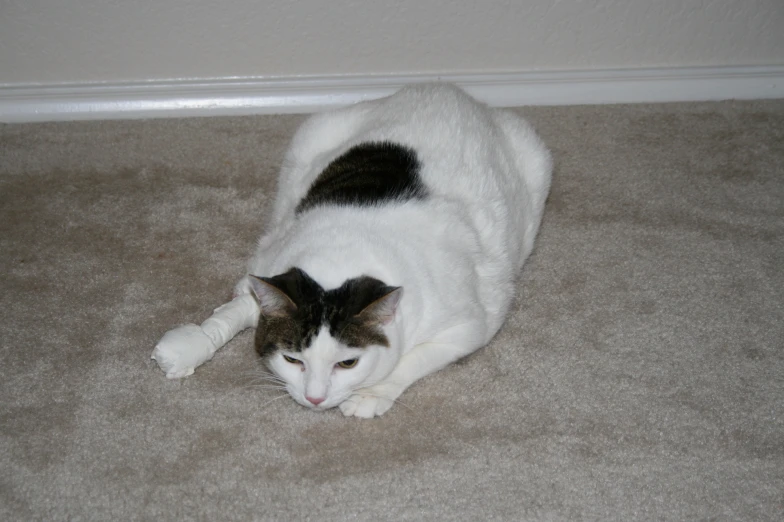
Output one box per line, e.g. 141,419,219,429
297,141,427,214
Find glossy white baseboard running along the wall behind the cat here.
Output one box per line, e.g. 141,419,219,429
0,65,784,123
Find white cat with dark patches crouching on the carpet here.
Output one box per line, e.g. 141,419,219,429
153,84,551,417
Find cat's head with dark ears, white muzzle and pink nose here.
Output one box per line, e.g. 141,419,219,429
250,268,403,410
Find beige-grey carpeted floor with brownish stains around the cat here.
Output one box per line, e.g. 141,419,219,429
0,96,784,521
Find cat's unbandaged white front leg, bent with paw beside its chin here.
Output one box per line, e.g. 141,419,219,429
339,323,486,419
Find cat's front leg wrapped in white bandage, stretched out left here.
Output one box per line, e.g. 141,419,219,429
152,294,259,379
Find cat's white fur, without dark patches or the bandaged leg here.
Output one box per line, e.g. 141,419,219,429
150,84,551,417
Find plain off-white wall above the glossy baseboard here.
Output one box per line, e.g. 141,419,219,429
0,0,784,85
